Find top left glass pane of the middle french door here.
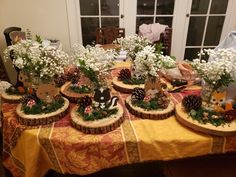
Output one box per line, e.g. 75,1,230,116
137,0,155,15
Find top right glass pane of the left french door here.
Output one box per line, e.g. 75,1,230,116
101,0,119,15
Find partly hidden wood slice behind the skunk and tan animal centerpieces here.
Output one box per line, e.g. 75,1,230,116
60,82,91,103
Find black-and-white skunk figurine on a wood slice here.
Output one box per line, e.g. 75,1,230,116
94,88,118,109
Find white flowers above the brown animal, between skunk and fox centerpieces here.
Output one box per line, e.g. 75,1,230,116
134,46,176,77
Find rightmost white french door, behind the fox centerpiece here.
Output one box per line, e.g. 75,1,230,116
172,0,236,60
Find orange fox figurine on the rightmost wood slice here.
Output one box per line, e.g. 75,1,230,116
210,91,226,112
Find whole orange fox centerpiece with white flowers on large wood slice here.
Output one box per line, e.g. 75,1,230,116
176,49,236,135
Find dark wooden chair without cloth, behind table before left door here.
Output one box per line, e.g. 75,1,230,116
96,27,125,44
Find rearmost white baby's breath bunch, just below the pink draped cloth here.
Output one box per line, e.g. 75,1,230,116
113,34,151,59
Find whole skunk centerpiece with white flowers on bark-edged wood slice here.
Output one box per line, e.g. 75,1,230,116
71,46,123,134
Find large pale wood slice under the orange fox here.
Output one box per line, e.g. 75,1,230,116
175,103,236,136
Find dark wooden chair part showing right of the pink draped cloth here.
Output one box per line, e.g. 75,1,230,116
154,27,172,55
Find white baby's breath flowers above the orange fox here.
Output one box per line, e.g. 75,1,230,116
191,49,236,90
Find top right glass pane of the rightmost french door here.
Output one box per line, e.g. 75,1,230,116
210,0,228,14
